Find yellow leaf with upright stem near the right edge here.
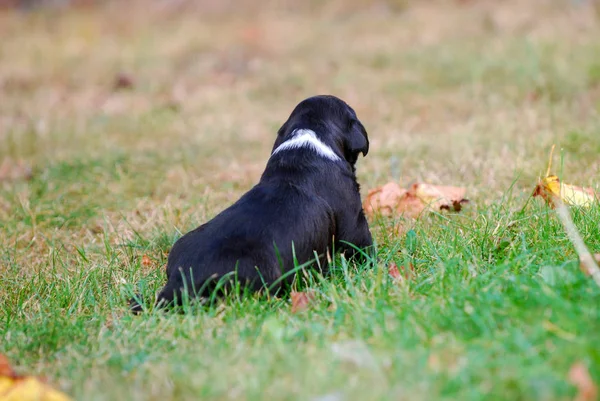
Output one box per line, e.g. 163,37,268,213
532,145,598,208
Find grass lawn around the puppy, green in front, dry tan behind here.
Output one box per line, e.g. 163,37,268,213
0,0,600,401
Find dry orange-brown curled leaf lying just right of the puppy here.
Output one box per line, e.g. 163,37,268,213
363,182,469,217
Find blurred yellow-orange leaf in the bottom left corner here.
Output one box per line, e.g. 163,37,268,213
0,355,72,401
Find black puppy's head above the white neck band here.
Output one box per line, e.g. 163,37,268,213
273,95,369,165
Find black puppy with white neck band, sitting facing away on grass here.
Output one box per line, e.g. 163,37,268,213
132,96,372,312
